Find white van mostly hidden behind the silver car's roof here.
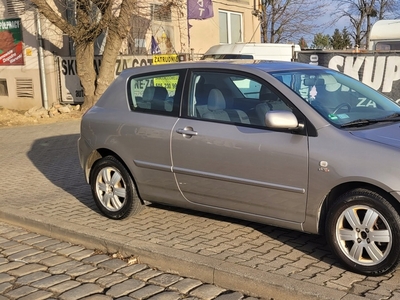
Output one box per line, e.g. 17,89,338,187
201,43,301,61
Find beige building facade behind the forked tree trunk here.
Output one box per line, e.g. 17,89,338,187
0,0,260,110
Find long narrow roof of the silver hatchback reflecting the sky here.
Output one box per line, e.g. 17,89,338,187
120,59,325,76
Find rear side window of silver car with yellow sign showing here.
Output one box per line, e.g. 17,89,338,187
128,72,182,115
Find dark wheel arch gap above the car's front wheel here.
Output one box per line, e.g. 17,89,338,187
318,181,400,234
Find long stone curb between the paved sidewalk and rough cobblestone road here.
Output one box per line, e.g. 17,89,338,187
0,207,356,300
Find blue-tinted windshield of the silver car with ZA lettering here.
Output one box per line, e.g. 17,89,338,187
271,69,400,127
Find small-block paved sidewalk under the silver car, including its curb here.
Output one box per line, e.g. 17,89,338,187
0,121,400,299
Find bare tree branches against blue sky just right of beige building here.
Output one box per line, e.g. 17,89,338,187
258,0,327,43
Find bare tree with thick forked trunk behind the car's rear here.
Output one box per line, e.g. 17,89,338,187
31,0,136,111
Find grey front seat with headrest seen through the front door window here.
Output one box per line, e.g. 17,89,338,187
203,89,250,124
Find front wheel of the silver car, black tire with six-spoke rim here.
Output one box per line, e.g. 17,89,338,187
325,189,400,276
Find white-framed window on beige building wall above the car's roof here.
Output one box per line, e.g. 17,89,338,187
219,10,243,44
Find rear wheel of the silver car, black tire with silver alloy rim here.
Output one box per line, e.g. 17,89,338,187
90,156,143,220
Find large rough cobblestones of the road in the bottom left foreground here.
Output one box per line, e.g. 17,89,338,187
0,222,257,300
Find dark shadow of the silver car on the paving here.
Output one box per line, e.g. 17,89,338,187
27,134,343,268
